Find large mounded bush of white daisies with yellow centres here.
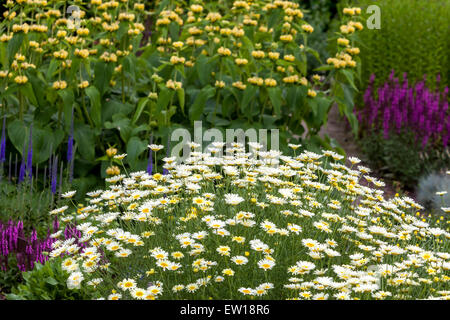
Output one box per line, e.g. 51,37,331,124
50,143,450,300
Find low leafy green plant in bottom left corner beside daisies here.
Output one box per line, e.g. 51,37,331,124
6,258,97,300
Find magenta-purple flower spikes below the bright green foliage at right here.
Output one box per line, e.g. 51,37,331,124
358,70,450,149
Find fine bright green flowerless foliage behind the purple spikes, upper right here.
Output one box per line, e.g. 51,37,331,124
353,0,450,89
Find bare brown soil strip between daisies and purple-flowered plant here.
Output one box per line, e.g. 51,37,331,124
319,105,415,199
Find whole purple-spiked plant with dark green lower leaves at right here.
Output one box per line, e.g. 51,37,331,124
357,71,450,189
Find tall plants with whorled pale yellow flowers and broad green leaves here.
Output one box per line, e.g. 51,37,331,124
0,0,359,183
